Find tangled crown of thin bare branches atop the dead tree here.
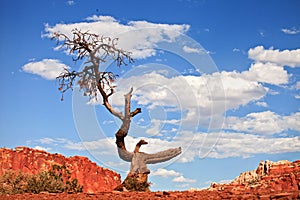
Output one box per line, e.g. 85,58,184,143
52,29,133,100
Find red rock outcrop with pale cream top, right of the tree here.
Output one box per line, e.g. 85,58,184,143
208,160,300,198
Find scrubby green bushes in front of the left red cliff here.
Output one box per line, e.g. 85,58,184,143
0,165,83,194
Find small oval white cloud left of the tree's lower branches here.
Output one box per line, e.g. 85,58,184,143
22,59,70,80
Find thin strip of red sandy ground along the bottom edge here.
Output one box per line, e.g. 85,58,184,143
0,190,300,200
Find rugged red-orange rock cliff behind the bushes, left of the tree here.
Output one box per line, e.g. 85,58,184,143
0,147,121,193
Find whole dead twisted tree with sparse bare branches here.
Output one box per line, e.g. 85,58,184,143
52,29,181,190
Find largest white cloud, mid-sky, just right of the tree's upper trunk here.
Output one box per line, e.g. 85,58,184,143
112,67,268,128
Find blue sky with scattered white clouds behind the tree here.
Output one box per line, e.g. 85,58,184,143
0,0,300,191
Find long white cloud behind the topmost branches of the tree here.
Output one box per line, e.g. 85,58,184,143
44,15,189,59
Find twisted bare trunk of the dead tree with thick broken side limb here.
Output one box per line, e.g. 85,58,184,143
98,80,181,191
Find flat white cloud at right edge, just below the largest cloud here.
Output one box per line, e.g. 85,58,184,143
226,111,300,135
